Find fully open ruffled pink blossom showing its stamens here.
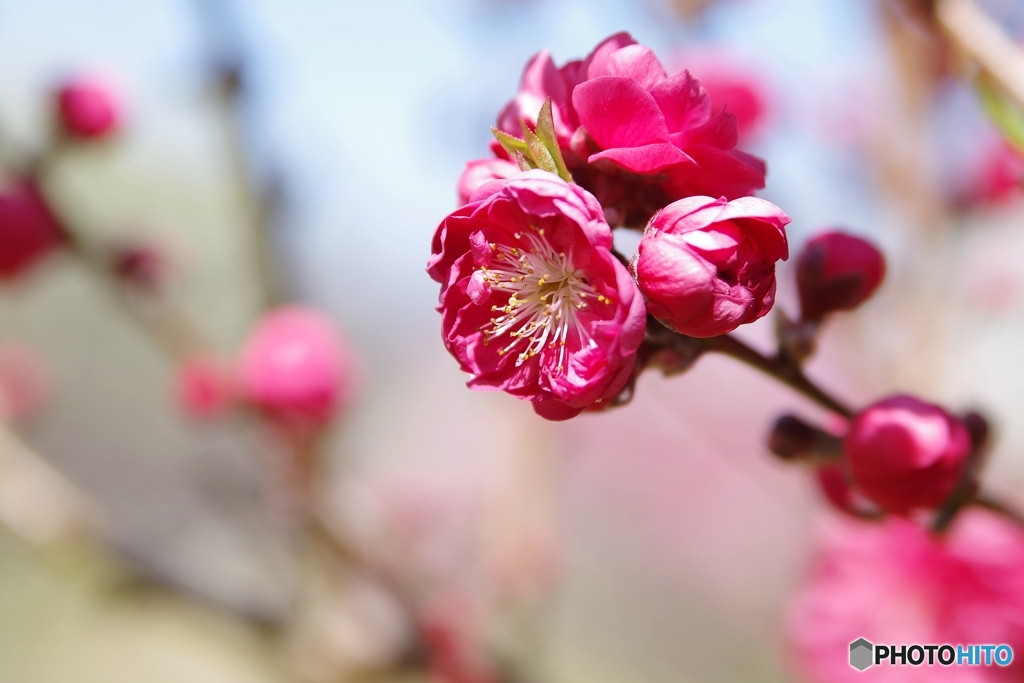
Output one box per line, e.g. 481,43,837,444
427,171,645,420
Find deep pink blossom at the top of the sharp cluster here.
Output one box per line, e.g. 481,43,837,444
498,33,765,226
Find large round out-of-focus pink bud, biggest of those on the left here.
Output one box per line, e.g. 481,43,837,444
239,306,354,427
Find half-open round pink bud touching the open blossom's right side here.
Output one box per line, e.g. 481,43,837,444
631,197,790,337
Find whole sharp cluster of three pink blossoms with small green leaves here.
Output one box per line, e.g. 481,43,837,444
427,34,790,420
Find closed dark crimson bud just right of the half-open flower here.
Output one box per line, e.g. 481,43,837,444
797,232,886,321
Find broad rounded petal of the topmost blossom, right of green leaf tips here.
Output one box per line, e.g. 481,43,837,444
572,76,669,150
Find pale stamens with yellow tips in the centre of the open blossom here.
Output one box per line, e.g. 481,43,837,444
480,225,610,374
